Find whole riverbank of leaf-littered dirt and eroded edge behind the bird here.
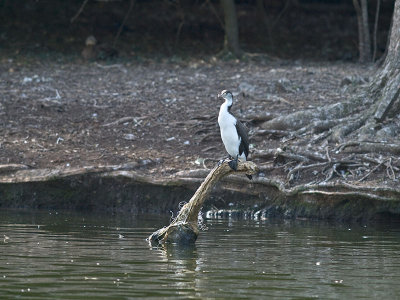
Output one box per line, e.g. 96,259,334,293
0,58,400,219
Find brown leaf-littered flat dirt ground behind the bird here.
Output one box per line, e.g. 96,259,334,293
0,58,375,180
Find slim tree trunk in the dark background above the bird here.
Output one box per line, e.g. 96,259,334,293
221,0,243,57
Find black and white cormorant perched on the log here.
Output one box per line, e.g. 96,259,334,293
218,90,252,179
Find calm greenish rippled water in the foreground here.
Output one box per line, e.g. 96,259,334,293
0,212,400,299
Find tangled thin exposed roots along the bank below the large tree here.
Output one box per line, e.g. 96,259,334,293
253,142,400,186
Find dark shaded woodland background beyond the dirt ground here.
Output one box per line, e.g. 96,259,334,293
0,0,394,61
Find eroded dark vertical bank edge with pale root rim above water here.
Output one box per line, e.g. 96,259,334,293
0,165,400,221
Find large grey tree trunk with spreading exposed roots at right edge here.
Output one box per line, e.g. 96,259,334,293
253,0,400,186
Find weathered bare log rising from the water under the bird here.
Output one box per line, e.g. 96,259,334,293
148,161,258,246
